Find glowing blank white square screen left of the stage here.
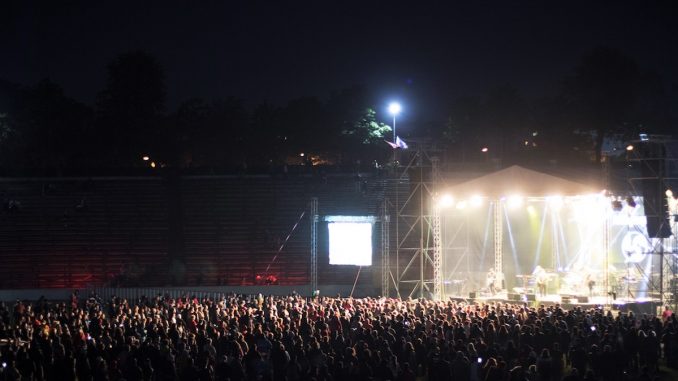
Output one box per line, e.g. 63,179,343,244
327,222,372,266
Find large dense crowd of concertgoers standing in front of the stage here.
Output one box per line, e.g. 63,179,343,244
0,295,678,381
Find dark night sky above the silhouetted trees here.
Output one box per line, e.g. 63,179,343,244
0,0,678,121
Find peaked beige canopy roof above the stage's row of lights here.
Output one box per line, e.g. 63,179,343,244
447,165,600,198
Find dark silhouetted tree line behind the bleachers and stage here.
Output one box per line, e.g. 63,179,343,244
0,47,676,170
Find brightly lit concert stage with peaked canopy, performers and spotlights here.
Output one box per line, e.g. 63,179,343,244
440,167,678,306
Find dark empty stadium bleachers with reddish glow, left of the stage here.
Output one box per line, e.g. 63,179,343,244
0,171,386,288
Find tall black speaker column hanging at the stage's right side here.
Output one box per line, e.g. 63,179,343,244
638,141,671,238
